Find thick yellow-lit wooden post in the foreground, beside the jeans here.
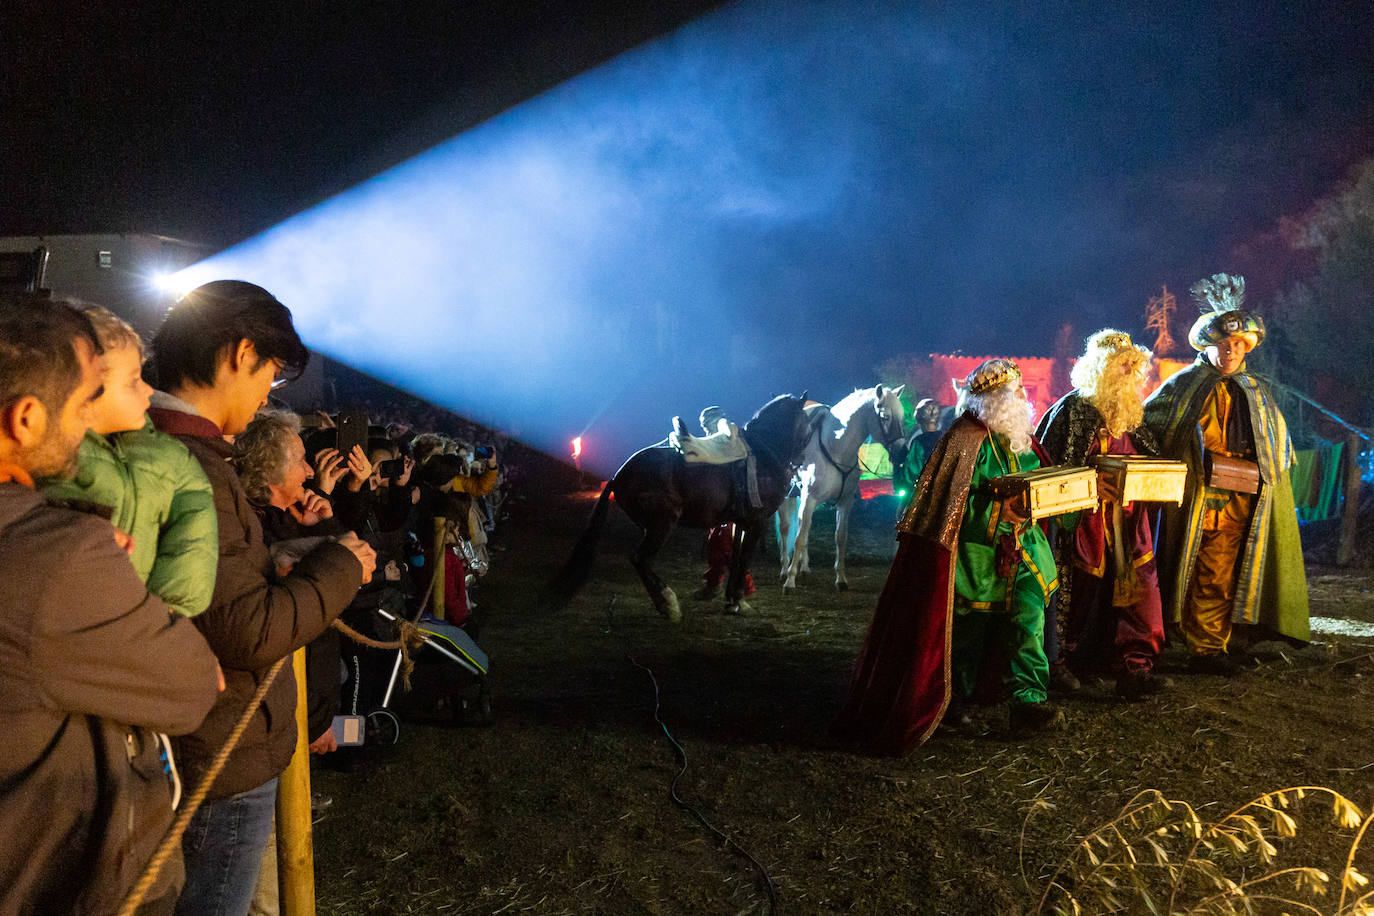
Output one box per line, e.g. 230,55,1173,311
276,648,315,916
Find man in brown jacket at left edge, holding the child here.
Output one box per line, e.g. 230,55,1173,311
0,294,218,913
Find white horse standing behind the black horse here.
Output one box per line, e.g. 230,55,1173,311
778,385,907,591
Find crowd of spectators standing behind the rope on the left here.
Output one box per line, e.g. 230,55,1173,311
0,280,510,913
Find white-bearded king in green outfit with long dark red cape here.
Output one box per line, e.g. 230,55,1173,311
833,360,1062,754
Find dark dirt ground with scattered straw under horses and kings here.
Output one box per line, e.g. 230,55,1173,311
315,497,1374,915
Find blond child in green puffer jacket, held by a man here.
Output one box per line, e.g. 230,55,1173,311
43,305,220,617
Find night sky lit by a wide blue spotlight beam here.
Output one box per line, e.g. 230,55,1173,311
0,0,1374,466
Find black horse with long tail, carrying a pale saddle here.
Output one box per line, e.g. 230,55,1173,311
545,393,811,623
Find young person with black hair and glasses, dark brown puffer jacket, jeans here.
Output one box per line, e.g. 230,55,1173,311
150,280,375,915
